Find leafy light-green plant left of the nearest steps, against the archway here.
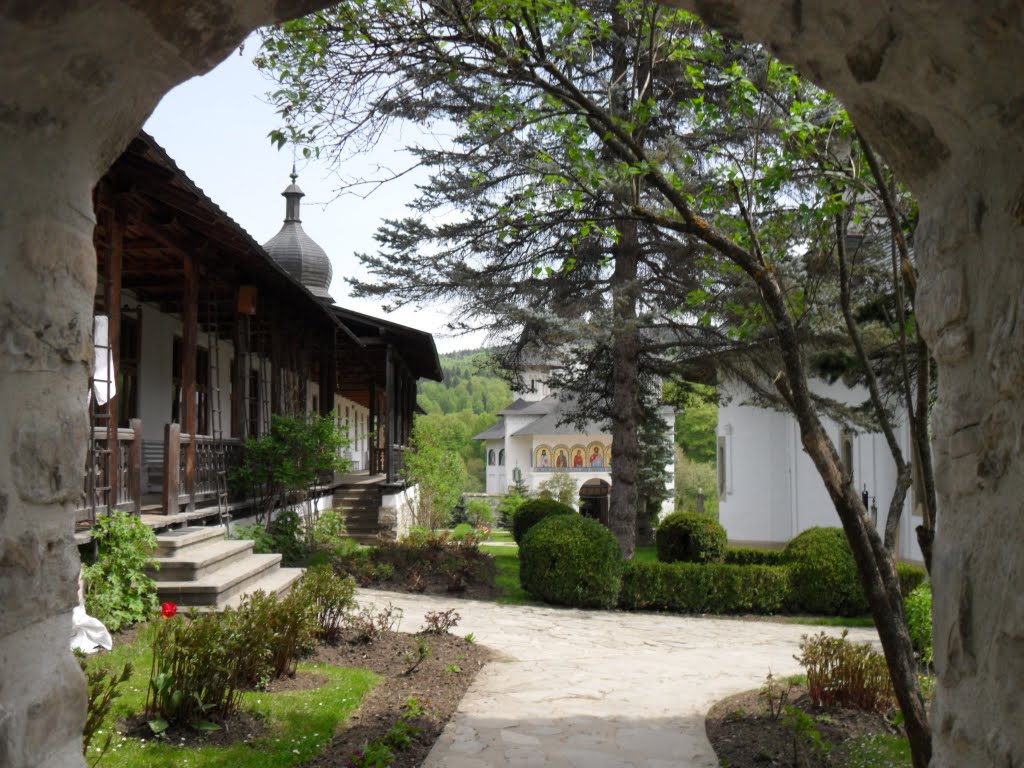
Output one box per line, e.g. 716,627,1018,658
82,510,159,632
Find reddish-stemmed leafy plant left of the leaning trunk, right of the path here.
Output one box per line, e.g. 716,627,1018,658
797,630,895,713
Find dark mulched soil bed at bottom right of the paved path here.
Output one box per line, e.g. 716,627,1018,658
706,686,898,768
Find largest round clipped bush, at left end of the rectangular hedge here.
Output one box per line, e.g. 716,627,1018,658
519,514,623,608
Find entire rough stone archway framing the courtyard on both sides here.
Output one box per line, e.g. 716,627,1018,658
0,0,1024,768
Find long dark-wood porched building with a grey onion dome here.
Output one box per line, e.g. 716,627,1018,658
78,133,441,526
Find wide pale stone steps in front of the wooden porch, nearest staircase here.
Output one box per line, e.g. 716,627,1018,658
151,525,302,610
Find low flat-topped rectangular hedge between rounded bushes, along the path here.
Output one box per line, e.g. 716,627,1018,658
618,560,792,613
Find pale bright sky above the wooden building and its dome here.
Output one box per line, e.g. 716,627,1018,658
145,38,483,351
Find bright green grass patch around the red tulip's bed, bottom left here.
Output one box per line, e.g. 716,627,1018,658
88,633,379,768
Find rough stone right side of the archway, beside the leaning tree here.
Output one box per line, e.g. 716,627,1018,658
663,0,1024,768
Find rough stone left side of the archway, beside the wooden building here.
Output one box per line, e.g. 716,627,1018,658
0,0,325,768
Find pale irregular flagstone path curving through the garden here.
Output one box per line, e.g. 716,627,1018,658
358,590,878,768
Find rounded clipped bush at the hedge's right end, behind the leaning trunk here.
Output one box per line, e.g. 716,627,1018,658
784,527,868,616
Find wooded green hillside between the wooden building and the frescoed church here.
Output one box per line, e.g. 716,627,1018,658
417,349,513,493
